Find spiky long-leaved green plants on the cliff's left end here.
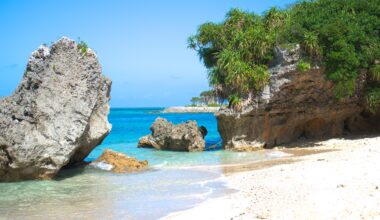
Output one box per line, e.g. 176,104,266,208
188,8,287,104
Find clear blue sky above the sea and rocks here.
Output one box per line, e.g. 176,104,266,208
0,0,294,107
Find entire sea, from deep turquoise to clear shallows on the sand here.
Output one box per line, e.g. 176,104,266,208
0,108,280,219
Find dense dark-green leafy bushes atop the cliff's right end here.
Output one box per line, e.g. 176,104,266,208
286,0,380,101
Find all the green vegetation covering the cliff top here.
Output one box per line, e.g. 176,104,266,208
189,0,380,109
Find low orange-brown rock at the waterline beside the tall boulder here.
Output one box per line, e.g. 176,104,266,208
91,149,148,173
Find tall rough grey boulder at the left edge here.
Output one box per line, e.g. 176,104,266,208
0,37,111,181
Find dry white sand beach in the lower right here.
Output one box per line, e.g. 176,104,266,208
167,137,380,220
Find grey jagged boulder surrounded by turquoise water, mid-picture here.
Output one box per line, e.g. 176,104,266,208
138,117,207,152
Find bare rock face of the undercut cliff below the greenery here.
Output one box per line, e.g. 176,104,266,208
216,46,380,149
